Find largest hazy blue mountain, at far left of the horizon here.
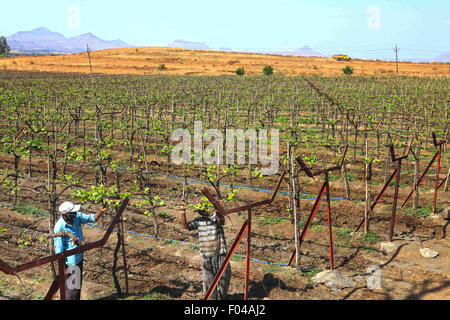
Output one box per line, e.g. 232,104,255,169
6,27,132,53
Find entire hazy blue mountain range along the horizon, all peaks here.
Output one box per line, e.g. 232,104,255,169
6,27,450,62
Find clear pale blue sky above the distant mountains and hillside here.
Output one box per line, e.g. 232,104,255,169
0,0,450,59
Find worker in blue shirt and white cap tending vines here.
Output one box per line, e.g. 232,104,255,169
54,201,106,300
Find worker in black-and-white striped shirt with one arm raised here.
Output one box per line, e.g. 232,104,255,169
181,199,231,300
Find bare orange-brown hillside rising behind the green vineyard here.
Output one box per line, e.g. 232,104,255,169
0,47,450,77
